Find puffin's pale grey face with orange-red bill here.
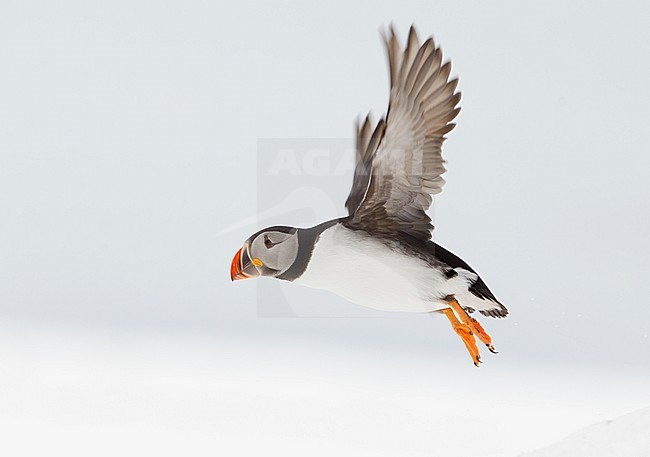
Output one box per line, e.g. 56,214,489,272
230,226,298,281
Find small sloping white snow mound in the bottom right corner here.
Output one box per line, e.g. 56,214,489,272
522,408,650,457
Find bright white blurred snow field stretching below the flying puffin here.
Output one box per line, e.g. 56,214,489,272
0,320,650,457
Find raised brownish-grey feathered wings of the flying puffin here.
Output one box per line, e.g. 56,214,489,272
346,27,460,240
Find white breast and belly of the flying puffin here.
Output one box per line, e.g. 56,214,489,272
294,225,468,312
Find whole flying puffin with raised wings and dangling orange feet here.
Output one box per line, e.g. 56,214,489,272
230,26,508,366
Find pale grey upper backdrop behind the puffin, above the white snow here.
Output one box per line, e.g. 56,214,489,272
0,1,650,370
